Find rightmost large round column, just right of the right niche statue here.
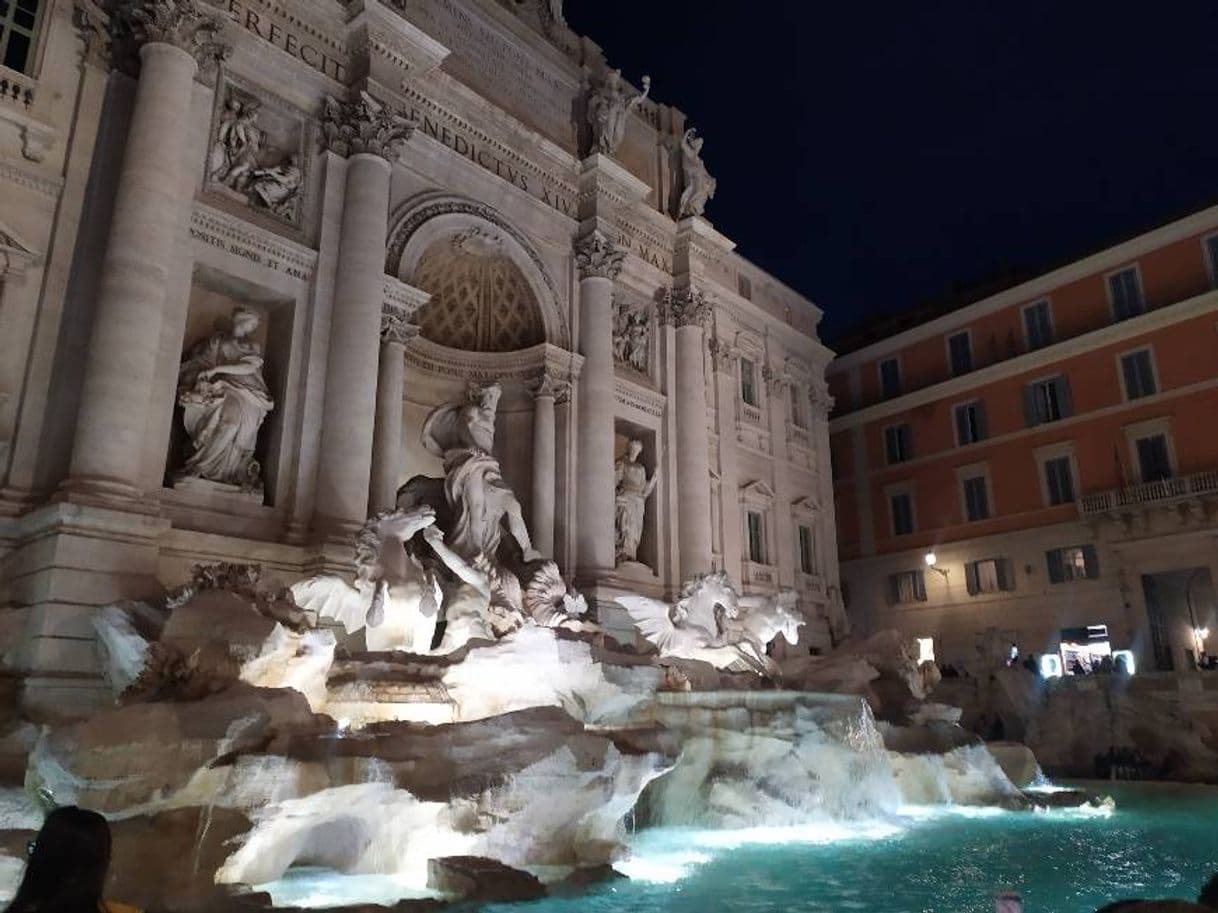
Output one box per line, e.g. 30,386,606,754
660,289,711,579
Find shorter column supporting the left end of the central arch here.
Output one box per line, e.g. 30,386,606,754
368,306,419,516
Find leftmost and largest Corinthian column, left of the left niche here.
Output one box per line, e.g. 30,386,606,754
65,0,223,500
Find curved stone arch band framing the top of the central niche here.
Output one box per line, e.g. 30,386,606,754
385,194,571,349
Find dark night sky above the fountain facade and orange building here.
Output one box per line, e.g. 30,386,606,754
565,0,1218,341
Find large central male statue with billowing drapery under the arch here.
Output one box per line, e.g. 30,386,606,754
414,383,541,564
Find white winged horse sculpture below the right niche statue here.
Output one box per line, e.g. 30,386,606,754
616,571,799,678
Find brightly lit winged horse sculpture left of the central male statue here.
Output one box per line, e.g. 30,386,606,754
291,505,491,654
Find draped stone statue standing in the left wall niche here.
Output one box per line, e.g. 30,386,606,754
175,307,275,494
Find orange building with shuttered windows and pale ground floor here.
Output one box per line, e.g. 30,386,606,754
829,207,1218,671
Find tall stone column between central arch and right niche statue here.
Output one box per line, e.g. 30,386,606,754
575,231,626,579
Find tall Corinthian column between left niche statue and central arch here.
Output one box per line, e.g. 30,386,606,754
313,94,413,536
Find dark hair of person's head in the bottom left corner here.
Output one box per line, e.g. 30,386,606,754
7,806,110,913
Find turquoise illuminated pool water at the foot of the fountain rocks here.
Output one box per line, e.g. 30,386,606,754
486,784,1218,913
